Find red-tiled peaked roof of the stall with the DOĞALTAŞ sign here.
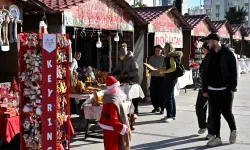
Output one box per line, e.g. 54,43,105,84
135,6,191,30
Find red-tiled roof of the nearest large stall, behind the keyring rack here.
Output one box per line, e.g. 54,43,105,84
16,0,146,24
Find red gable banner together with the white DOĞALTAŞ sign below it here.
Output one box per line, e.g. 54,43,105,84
148,13,183,48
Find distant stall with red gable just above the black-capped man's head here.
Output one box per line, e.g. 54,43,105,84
213,20,233,45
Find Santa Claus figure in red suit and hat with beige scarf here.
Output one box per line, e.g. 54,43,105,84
99,76,131,150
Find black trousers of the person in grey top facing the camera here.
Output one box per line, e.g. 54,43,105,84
150,76,164,110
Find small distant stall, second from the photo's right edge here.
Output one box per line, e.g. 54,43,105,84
231,24,247,56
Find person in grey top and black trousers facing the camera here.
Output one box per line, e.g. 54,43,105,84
149,45,165,114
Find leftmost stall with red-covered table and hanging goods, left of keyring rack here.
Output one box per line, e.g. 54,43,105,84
0,0,23,149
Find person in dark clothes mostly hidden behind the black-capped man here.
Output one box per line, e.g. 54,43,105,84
195,42,213,140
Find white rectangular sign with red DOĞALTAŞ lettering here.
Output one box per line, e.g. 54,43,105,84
154,30,183,48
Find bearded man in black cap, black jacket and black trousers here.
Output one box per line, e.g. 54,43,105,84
202,34,237,146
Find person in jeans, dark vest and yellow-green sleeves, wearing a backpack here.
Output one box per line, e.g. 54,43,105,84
158,43,183,123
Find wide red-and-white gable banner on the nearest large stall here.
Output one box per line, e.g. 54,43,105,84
64,0,134,31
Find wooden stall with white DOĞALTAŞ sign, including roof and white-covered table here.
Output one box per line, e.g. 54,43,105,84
135,6,193,95
